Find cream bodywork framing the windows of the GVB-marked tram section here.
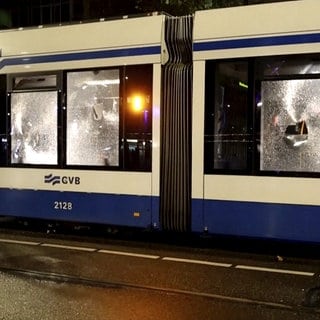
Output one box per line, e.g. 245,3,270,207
0,15,165,200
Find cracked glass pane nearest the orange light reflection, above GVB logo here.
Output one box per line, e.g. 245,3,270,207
67,69,120,166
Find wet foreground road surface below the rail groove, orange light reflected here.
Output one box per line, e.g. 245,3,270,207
0,273,319,320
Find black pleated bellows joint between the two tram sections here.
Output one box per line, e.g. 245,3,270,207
160,17,193,232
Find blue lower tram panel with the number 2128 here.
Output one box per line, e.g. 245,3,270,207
0,189,158,227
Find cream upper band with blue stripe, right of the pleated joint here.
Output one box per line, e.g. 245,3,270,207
194,0,320,60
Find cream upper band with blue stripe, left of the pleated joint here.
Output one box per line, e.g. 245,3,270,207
0,15,164,73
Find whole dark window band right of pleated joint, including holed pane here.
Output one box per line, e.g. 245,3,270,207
204,53,320,176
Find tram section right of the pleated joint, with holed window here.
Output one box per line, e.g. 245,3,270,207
192,1,320,242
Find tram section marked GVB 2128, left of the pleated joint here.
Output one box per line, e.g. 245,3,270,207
0,16,163,227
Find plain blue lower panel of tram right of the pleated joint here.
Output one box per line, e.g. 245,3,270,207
193,200,320,242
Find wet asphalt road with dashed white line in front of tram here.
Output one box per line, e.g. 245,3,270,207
0,233,320,320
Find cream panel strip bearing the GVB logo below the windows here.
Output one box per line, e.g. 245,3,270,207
0,168,152,196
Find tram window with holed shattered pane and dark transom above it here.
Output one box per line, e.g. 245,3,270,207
255,54,320,173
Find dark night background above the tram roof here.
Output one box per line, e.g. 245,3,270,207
0,0,296,29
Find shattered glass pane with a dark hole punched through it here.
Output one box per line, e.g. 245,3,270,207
260,79,320,172
